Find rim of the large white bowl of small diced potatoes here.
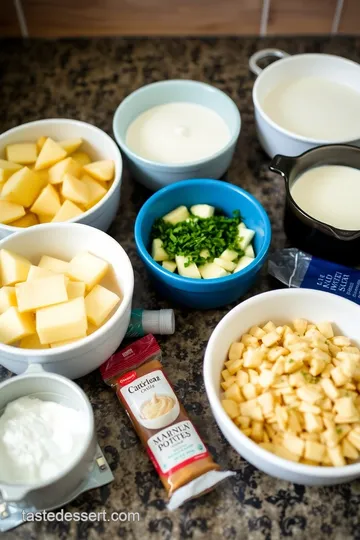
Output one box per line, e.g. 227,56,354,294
203,289,360,479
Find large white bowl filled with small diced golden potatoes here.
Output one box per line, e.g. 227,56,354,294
204,289,360,485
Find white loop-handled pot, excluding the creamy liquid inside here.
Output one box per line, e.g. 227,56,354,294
249,49,360,157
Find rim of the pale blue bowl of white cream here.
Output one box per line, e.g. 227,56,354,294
112,79,241,171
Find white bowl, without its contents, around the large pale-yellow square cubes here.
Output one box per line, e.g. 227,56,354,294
0,223,134,379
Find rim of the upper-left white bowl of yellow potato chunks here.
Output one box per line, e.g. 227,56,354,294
0,118,123,234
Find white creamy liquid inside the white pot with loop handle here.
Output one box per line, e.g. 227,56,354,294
262,77,360,141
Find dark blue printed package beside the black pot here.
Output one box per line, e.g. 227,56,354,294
269,248,360,305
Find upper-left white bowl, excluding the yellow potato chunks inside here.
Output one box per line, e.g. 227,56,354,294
0,118,123,239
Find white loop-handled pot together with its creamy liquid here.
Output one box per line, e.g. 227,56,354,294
249,49,360,157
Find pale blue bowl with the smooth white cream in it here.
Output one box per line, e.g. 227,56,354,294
113,80,241,190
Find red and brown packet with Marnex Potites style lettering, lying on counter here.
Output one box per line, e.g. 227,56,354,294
100,334,235,510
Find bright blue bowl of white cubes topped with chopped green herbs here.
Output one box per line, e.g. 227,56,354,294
135,179,271,309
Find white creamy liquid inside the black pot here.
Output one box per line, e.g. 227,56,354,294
290,165,360,231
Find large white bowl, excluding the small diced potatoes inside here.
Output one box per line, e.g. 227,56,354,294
204,289,360,485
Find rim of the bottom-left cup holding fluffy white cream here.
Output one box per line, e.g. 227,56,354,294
0,370,96,496
